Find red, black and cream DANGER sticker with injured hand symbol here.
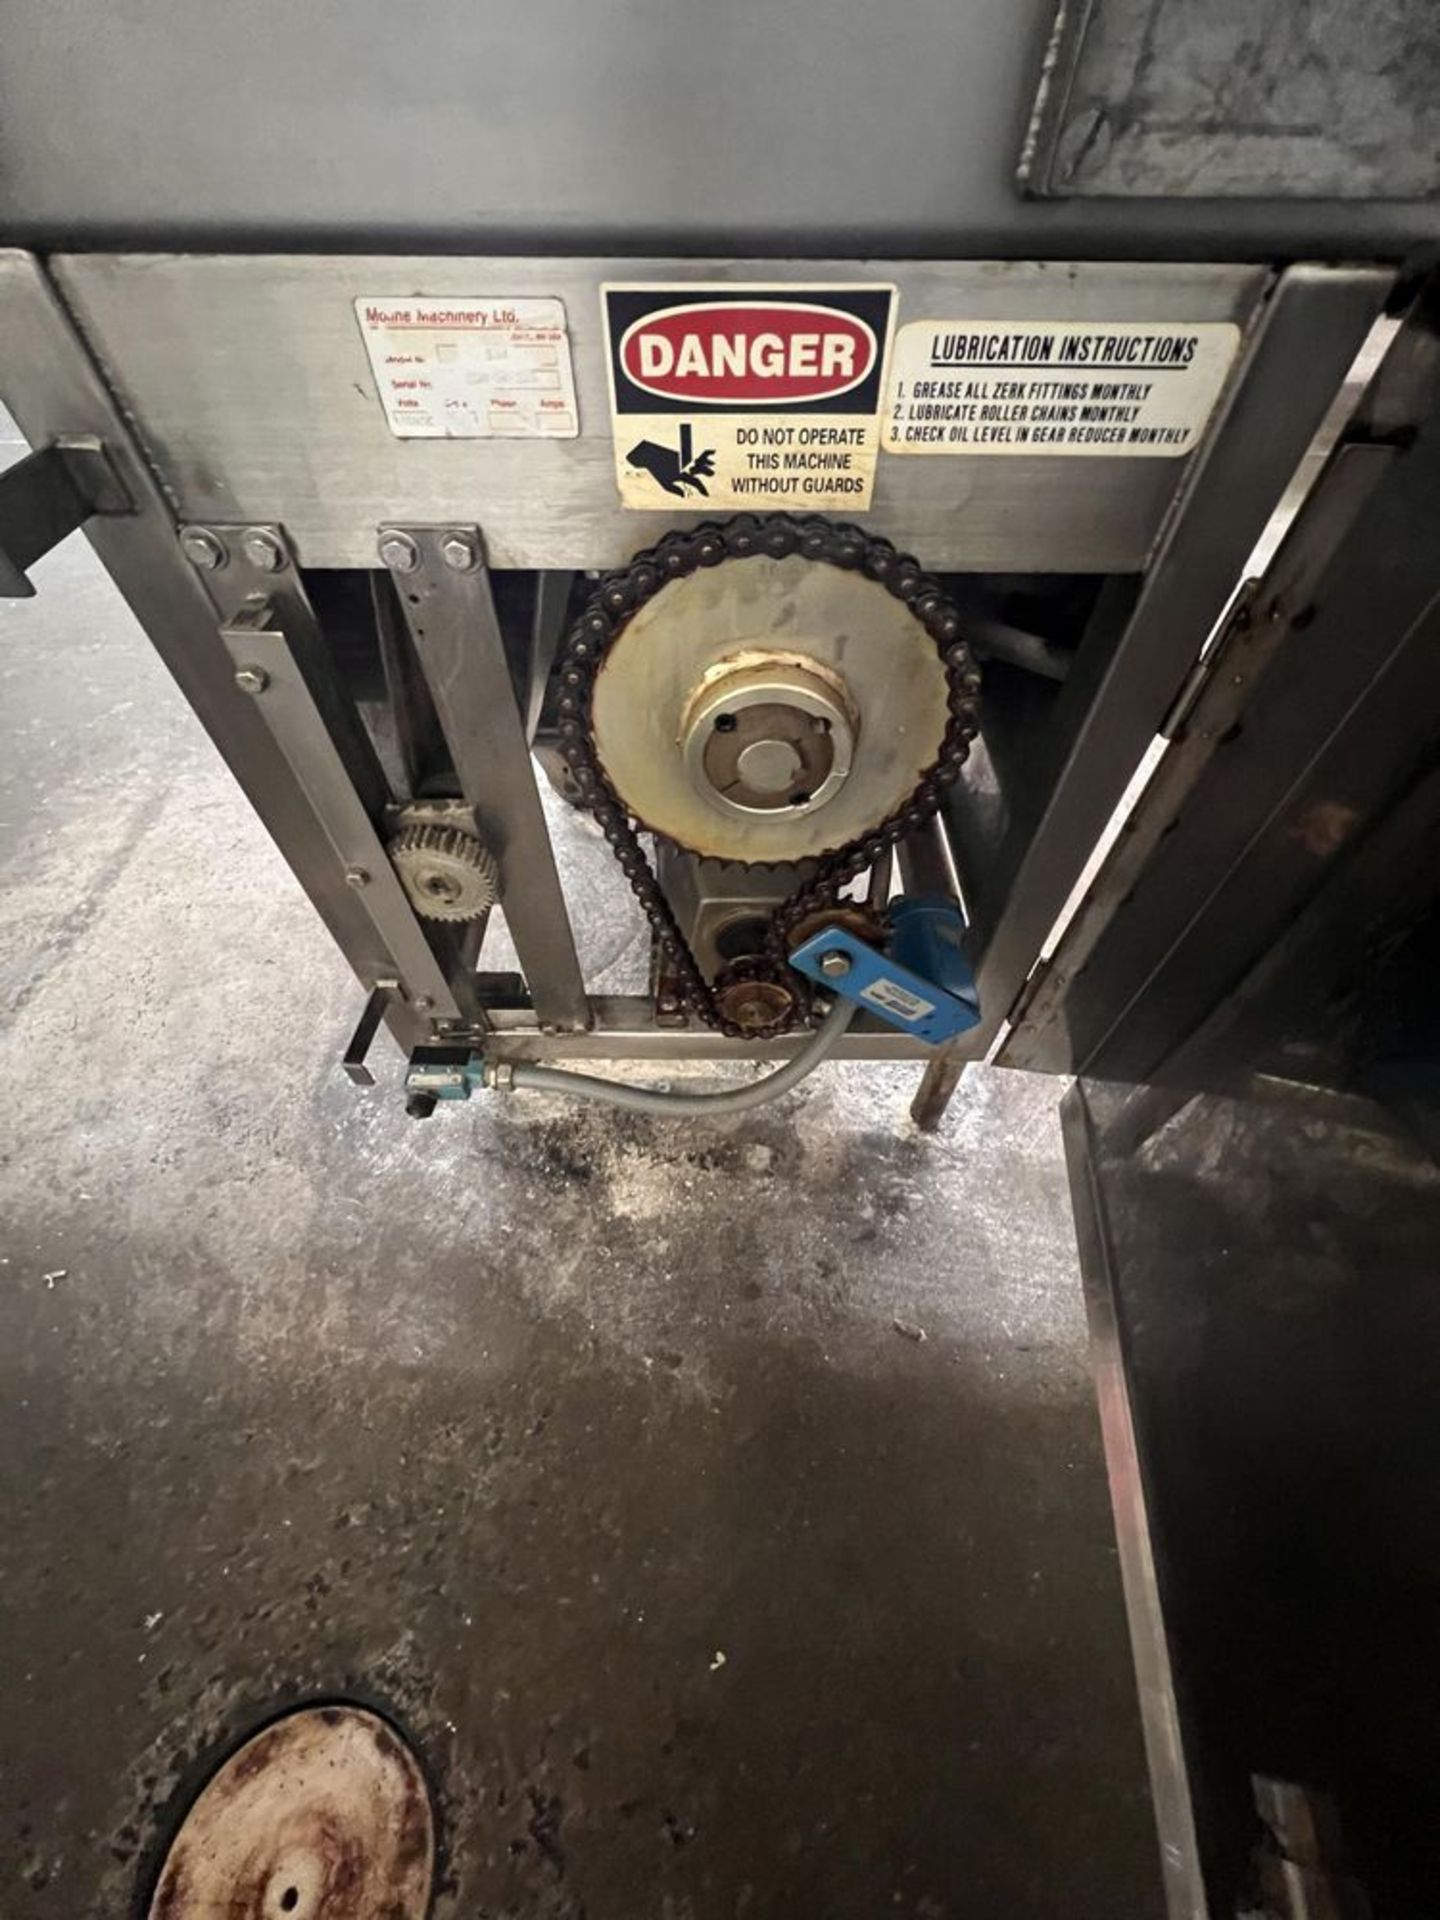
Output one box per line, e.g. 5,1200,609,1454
601,284,895,511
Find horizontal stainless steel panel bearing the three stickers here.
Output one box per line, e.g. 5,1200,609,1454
52,253,1271,572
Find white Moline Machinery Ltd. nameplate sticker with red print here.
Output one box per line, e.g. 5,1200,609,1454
355,294,580,440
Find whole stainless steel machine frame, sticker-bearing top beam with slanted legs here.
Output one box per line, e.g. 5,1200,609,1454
0,252,1394,1121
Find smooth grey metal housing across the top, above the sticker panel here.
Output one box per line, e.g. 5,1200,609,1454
0,0,1440,259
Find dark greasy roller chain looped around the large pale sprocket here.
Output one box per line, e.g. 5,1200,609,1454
559,513,979,1039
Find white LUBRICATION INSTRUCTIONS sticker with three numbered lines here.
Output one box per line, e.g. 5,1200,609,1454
885,321,1240,459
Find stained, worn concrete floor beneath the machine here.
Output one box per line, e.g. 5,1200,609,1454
0,439,1156,1920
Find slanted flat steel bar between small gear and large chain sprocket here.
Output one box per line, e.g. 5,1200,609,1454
378,526,589,1031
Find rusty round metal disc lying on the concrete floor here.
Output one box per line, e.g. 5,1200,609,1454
150,1707,434,1920
